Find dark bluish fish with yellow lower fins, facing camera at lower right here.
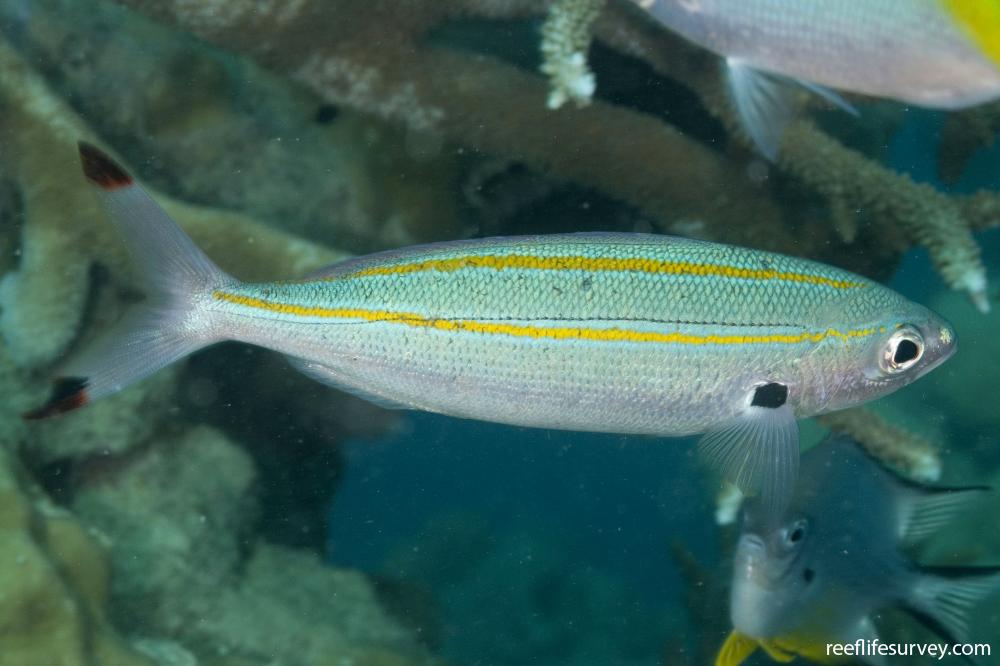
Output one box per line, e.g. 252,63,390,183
716,438,1000,666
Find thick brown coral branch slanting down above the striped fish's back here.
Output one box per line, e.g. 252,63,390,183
111,0,836,256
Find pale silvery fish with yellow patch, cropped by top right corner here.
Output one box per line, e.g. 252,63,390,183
635,0,1000,159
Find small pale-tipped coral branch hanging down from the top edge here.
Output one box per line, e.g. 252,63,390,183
541,0,605,109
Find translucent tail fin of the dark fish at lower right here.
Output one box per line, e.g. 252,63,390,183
903,567,1000,643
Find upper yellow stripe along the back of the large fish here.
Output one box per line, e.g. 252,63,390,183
338,254,867,289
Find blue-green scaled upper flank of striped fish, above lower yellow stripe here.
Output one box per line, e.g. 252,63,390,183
256,234,872,327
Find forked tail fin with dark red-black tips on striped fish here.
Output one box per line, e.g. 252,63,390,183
24,142,234,419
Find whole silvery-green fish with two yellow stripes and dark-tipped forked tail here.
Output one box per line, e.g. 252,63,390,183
28,144,955,507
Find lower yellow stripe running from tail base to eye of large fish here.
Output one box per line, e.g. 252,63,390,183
212,291,885,345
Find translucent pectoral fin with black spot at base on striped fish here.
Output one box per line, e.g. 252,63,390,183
700,384,799,519
